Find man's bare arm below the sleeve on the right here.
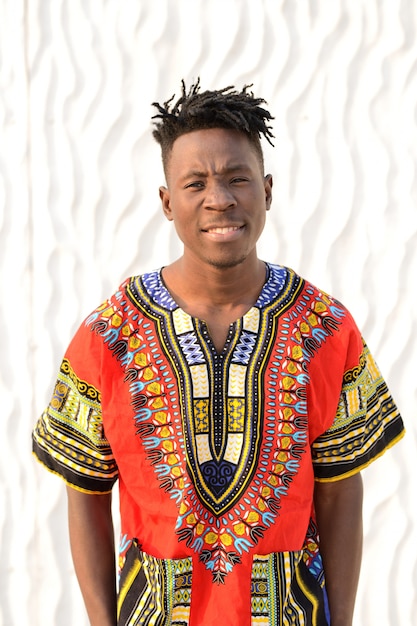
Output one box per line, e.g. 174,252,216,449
314,473,363,626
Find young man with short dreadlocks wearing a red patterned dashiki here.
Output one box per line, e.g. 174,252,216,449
34,83,403,626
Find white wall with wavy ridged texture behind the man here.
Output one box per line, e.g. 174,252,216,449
0,0,417,626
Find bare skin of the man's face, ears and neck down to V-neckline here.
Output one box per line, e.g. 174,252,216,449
160,129,272,352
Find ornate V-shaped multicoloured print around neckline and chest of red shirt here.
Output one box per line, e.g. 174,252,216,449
90,268,344,583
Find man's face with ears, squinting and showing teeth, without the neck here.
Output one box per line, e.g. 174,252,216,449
160,128,272,268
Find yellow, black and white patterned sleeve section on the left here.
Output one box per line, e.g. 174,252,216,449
33,352,118,493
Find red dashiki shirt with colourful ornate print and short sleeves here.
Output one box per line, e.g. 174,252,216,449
34,265,403,626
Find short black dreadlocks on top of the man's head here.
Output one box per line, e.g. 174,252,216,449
152,78,274,172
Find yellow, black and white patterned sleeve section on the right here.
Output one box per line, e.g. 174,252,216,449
312,342,404,482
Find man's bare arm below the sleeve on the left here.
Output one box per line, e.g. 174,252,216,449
67,487,117,626
